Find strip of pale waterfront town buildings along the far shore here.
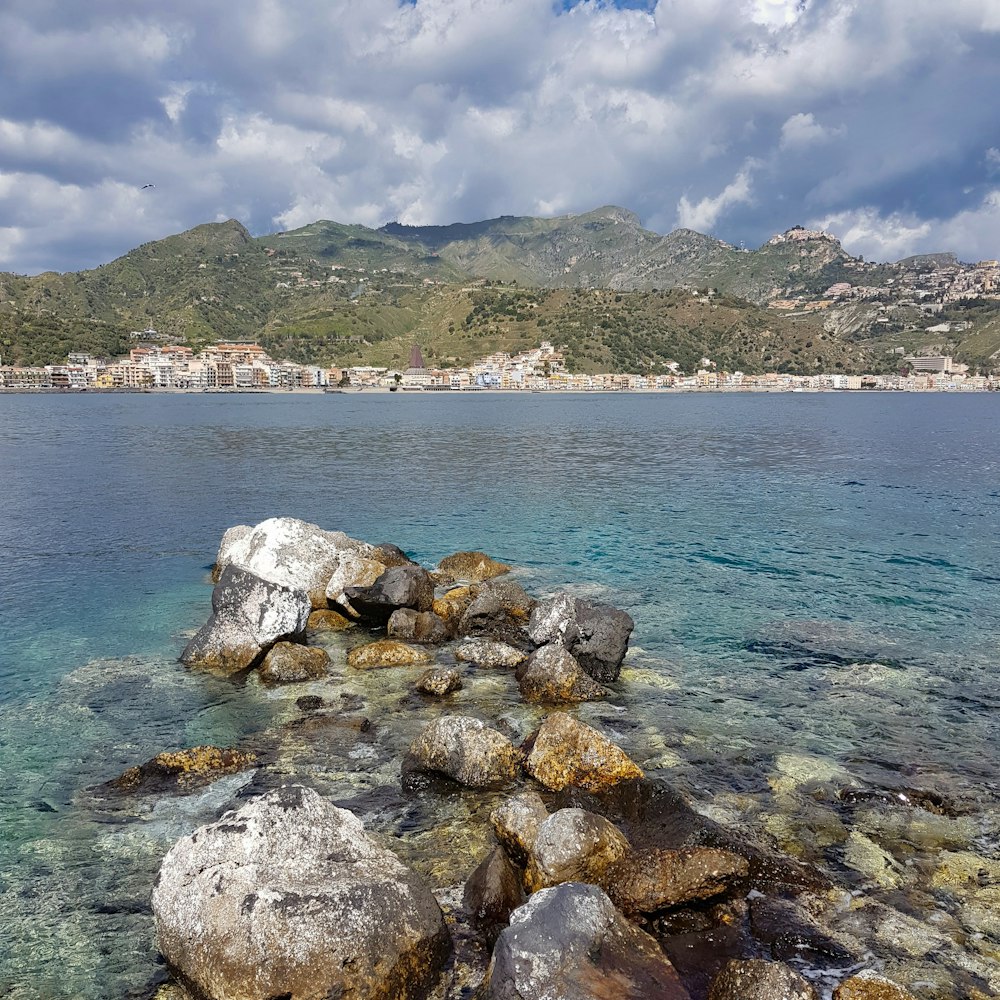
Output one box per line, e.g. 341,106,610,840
0,340,1000,392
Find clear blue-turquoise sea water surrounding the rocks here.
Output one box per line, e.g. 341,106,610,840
0,392,1000,1000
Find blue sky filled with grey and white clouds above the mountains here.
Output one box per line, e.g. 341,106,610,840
0,0,1000,274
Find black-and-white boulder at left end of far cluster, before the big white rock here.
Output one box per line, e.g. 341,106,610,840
181,566,310,674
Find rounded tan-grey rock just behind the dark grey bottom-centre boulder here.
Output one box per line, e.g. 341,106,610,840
524,809,629,892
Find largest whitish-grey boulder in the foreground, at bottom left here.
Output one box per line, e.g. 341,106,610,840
153,786,450,1000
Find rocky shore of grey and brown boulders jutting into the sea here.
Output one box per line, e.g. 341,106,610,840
102,518,1000,1000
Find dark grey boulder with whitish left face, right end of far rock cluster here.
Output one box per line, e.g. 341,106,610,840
528,593,635,684
